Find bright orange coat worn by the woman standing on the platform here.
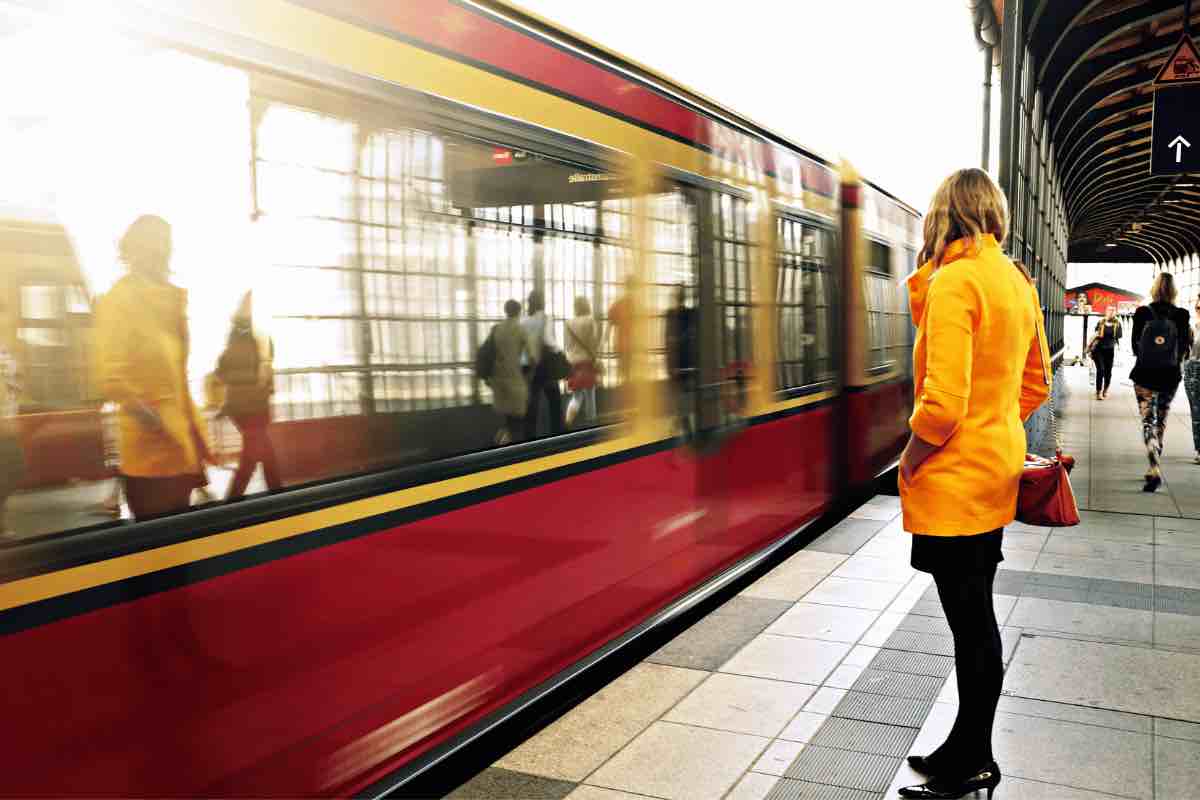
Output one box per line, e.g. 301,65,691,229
900,235,1050,536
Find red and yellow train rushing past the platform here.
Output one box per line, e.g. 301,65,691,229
0,0,919,796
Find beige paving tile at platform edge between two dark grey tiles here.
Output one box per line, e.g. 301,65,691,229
496,663,708,781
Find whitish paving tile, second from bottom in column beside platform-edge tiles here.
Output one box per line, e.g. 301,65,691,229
662,673,817,736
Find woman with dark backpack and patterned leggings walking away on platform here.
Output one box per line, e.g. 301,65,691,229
1129,272,1192,492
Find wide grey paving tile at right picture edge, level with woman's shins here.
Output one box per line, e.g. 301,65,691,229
1004,636,1200,724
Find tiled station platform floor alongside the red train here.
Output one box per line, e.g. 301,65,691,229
449,367,1200,800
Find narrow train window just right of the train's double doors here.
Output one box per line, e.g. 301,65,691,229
775,217,833,390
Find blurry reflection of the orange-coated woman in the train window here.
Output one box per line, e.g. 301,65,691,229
96,215,211,519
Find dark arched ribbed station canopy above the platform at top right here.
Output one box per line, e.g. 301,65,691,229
988,0,1200,263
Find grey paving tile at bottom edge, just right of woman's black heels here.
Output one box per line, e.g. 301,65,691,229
992,712,1153,799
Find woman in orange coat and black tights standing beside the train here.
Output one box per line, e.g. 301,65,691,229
900,169,1050,798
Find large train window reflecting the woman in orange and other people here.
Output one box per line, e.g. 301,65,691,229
0,21,638,537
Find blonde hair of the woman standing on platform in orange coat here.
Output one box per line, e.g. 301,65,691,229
919,168,1008,270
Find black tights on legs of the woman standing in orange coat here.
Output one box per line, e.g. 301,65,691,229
930,564,1004,777
